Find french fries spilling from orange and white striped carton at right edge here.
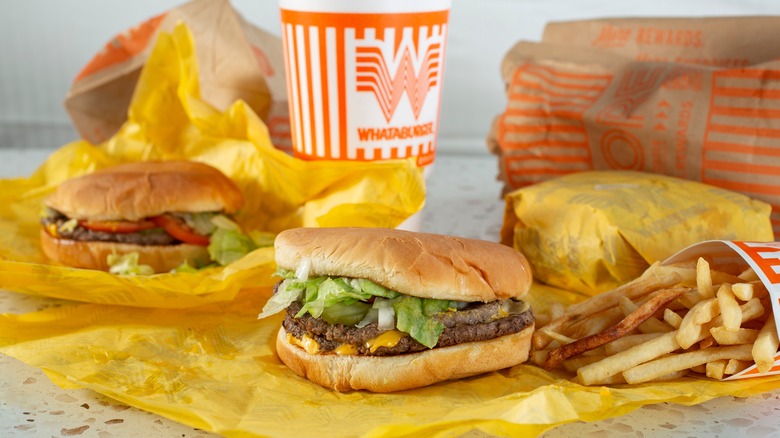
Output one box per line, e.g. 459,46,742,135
531,240,780,385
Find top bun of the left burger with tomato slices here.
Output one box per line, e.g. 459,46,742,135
45,161,243,220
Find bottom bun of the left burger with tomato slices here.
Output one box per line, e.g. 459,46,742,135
41,230,210,273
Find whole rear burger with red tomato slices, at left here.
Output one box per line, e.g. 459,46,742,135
40,161,243,273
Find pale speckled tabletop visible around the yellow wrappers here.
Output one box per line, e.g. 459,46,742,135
0,149,780,438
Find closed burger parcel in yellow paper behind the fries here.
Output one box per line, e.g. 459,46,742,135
501,171,773,294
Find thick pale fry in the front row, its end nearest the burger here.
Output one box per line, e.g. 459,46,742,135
577,332,680,385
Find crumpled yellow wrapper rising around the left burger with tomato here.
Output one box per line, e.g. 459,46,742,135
0,24,425,307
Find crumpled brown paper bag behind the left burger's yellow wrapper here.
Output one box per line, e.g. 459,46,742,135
65,0,292,150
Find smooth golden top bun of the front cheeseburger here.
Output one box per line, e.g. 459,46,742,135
274,228,532,302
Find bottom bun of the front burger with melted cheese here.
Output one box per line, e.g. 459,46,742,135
276,325,534,392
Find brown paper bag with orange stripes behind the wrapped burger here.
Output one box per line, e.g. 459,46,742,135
488,19,780,238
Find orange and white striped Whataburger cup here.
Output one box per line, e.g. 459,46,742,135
279,0,451,166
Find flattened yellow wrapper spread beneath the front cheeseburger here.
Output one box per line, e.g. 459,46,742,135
0,285,780,437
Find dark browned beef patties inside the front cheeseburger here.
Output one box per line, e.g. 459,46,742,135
282,294,534,356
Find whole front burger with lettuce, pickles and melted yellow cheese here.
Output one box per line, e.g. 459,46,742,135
259,228,534,392
